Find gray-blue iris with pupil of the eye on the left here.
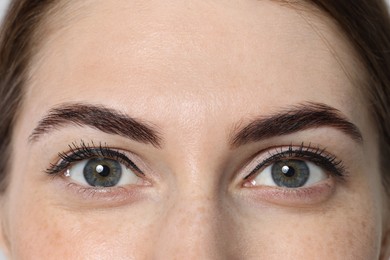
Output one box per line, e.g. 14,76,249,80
83,158,122,187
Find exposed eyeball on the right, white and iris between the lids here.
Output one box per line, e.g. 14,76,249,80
250,159,329,188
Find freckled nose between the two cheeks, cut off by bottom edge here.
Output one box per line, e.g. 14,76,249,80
156,180,223,259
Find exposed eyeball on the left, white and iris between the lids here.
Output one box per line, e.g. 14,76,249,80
65,157,142,187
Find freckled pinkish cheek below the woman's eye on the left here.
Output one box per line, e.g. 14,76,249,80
4,162,157,259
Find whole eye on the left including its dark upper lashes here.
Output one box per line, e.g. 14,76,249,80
46,140,150,188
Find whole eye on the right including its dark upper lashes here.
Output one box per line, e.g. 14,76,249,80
243,144,347,189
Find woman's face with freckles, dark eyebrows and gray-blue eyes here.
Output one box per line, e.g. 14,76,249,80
1,0,387,259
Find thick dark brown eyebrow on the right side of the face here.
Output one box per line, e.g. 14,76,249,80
230,102,363,147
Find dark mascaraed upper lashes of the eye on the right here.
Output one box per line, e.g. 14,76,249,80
244,143,347,180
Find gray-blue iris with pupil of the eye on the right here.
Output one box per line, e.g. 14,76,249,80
271,160,310,188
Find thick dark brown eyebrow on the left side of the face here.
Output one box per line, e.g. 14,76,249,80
29,103,161,147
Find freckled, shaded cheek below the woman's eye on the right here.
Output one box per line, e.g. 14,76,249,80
234,179,382,260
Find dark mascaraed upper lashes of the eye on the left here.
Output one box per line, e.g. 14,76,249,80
46,140,143,175
